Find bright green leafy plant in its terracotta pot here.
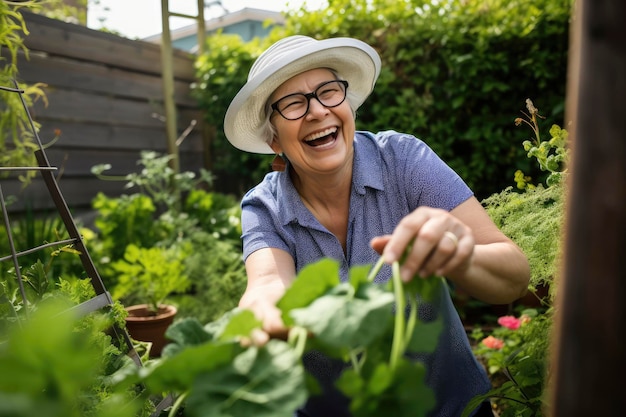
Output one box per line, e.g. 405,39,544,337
112,244,189,357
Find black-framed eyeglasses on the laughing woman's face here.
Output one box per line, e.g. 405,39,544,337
271,80,348,120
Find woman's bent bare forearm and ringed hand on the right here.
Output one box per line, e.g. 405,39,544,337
372,197,530,304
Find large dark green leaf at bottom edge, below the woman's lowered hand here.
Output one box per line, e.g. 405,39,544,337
185,340,307,417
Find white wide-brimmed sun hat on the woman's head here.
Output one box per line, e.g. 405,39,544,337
224,35,380,154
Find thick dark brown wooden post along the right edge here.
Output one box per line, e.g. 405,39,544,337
550,0,626,417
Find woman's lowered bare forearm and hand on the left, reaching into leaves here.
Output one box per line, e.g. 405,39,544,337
239,248,296,338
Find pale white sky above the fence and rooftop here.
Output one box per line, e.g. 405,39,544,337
87,0,319,39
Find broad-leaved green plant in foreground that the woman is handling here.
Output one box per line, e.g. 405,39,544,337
122,259,444,417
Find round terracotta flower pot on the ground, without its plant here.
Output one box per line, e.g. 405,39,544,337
126,304,177,357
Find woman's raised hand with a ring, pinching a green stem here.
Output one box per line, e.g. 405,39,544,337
371,207,475,282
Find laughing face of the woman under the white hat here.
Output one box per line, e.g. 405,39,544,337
270,68,355,173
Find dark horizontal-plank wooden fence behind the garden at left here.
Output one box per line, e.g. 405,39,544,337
2,13,208,211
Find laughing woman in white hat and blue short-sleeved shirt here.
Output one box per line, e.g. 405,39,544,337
225,36,529,417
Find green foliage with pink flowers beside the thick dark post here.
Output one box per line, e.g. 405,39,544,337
465,99,569,417
